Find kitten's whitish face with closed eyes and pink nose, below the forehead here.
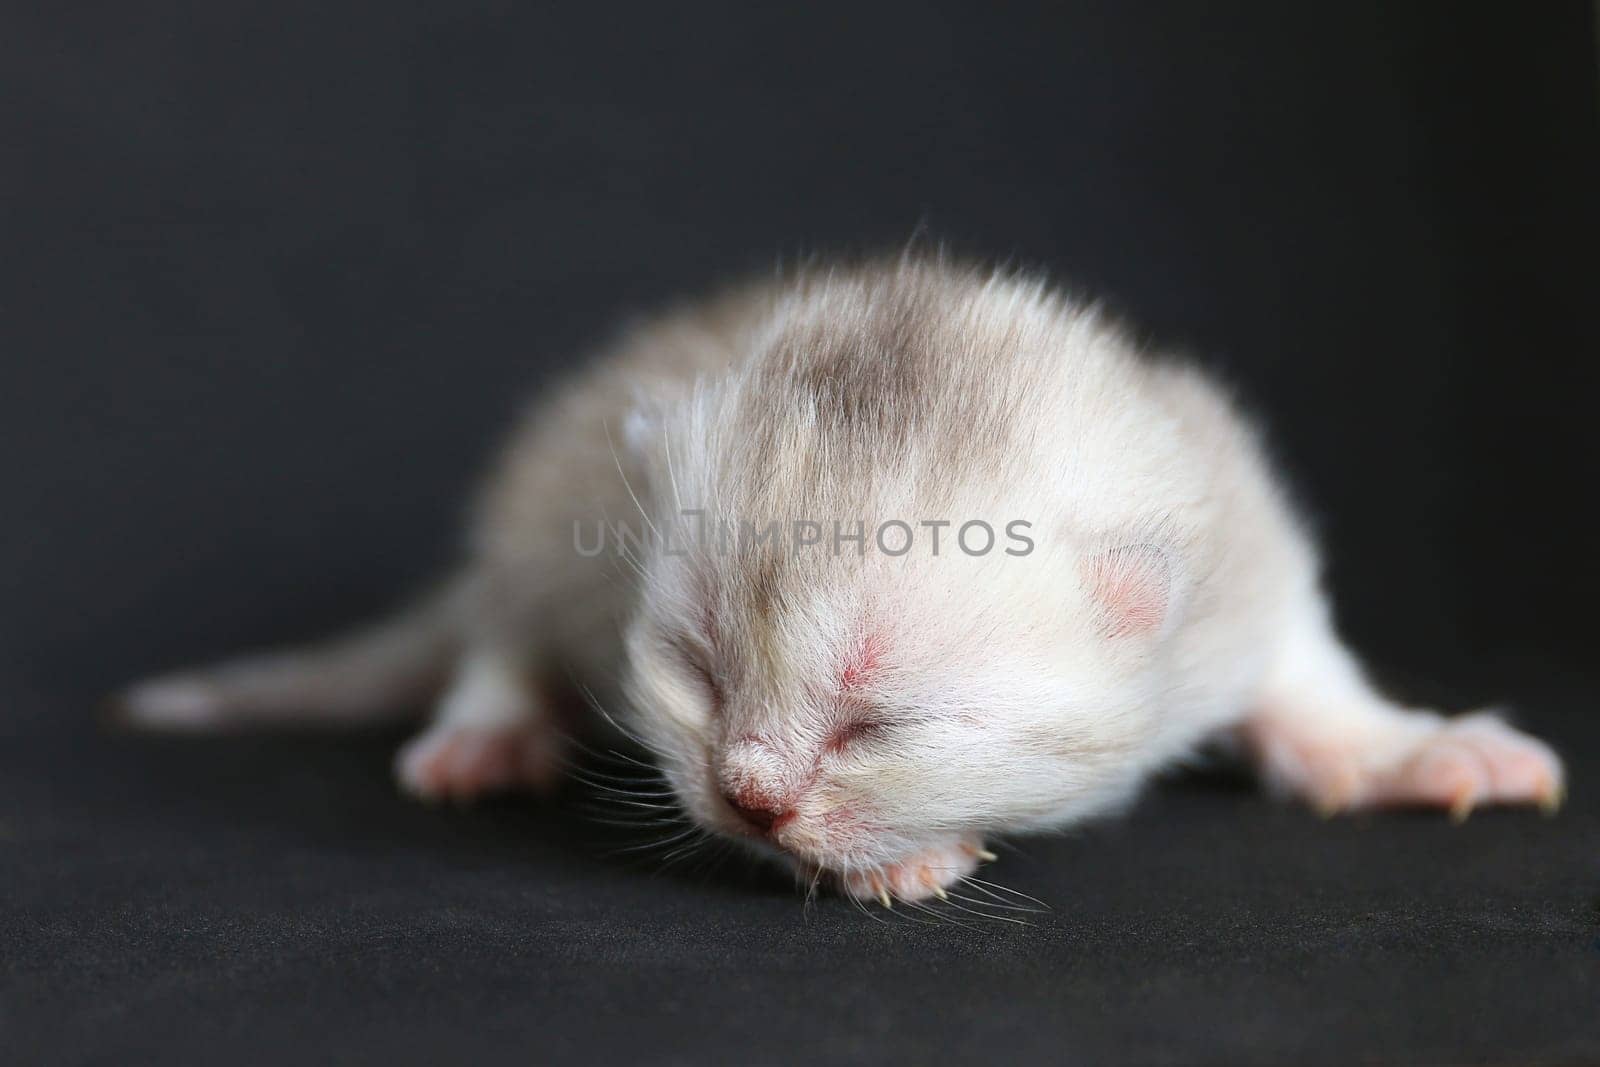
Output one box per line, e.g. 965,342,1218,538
627,499,1165,872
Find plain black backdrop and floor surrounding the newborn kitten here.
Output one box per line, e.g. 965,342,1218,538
0,0,1600,1062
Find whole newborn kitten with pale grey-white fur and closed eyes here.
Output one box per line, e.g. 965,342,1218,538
123,259,1562,904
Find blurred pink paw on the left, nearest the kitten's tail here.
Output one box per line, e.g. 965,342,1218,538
395,723,562,801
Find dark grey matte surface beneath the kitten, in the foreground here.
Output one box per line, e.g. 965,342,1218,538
9,670,1600,1064
